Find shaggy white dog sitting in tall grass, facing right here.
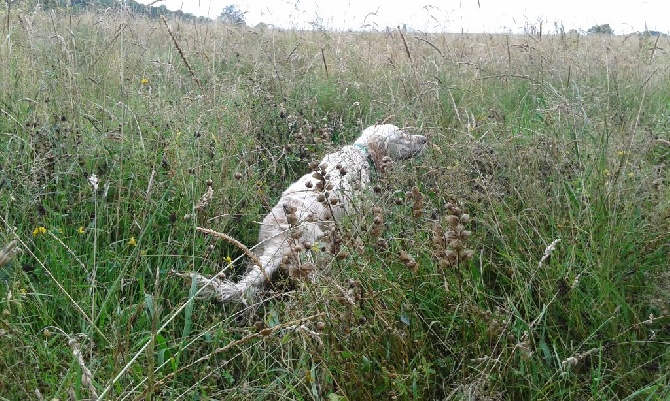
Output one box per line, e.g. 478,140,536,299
198,124,427,302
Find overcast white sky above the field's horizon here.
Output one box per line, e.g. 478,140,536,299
140,0,670,34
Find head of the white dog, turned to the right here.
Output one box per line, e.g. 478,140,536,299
356,124,428,160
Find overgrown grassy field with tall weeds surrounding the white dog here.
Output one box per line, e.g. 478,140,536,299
0,9,670,400
